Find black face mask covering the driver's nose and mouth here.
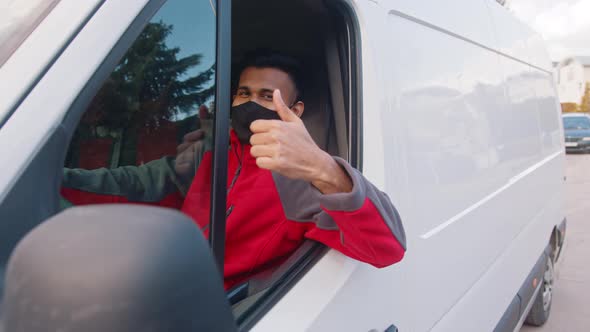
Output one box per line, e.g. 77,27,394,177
231,101,281,144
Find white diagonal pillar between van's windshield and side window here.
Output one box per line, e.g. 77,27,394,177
0,0,147,205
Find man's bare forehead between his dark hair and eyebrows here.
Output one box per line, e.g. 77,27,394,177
239,67,295,91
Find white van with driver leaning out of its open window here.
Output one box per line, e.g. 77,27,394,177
0,0,565,332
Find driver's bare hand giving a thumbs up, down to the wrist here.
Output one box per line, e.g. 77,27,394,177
250,89,352,194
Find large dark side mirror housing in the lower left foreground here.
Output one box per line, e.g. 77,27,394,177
0,204,237,332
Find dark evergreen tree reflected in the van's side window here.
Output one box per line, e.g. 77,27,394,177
82,22,215,132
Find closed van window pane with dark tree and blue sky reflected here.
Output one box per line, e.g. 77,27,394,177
61,0,216,208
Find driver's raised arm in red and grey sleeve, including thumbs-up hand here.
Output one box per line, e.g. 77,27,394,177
250,90,405,267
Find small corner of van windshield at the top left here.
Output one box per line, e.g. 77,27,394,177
0,0,59,67
